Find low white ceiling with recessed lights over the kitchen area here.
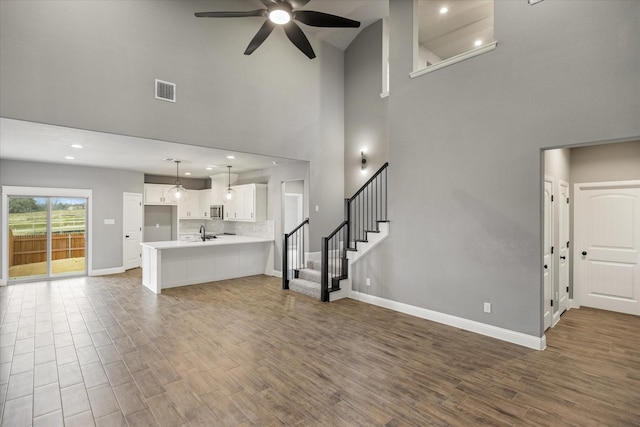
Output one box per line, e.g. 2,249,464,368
0,118,299,178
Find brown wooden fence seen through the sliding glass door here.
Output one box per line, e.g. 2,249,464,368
9,230,85,267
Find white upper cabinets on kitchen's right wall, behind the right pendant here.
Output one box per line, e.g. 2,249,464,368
224,184,267,221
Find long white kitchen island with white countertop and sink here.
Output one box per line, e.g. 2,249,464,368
140,235,273,294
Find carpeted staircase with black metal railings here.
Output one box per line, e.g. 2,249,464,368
282,163,389,302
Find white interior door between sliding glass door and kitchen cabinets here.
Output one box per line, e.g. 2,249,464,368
122,193,142,270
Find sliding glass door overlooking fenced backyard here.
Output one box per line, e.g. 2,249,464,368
8,195,87,281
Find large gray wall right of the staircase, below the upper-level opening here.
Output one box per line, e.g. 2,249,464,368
346,0,640,336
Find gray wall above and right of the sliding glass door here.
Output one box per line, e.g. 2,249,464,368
0,160,144,277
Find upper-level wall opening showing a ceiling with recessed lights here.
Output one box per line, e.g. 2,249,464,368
411,0,496,77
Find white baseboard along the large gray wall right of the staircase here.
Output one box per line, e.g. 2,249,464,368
349,291,547,350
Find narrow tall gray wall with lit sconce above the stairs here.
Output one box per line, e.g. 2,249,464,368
344,21,389,197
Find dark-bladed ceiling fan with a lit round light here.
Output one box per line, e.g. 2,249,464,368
195,0,360,59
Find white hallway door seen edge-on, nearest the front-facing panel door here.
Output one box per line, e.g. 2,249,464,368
554,181,571,320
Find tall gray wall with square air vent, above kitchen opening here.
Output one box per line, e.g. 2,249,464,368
0,0,344,252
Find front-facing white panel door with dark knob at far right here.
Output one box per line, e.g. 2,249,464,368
574,181,640,314
